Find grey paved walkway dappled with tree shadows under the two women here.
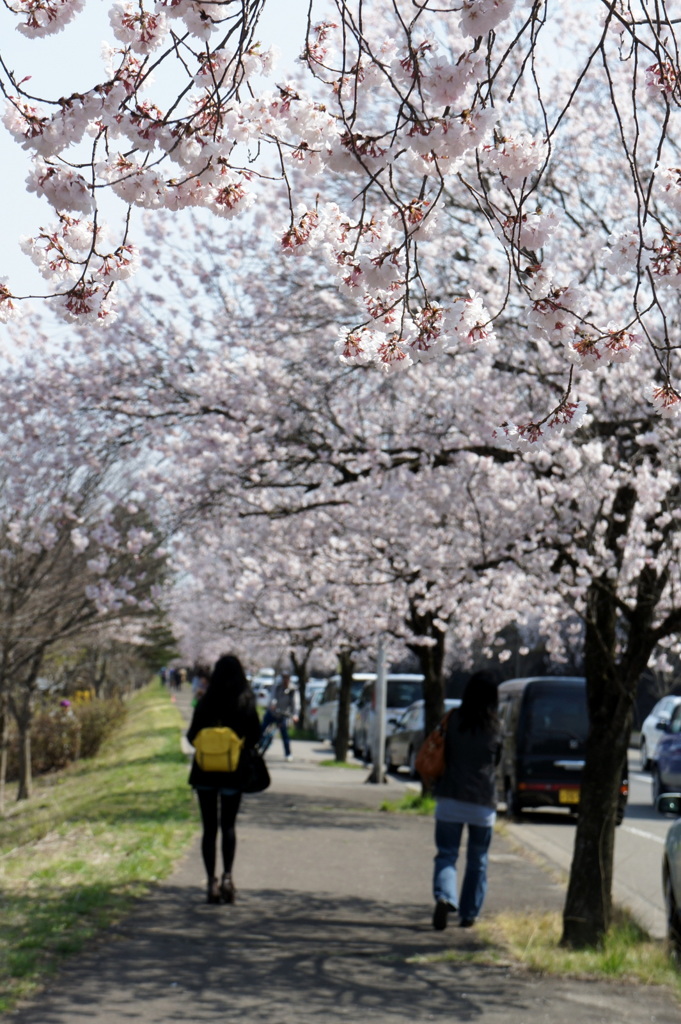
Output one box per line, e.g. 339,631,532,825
7,701,680,1024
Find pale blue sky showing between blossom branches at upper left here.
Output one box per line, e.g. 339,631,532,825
0,0,307,294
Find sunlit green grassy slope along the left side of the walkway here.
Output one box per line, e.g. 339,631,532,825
0,684,197,1013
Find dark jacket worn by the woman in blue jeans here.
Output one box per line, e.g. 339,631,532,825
433,710,501,809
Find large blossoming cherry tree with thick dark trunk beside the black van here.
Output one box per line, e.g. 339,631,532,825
58,226,681,944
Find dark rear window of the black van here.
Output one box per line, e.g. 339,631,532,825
524,688,589,754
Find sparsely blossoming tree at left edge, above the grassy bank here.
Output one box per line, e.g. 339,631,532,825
0,357,165,799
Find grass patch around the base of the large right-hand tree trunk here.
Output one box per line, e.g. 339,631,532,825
478,909,681,999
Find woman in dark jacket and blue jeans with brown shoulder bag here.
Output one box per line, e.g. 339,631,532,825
433,672,501,931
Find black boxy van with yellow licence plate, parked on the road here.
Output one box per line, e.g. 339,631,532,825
498,676,629,824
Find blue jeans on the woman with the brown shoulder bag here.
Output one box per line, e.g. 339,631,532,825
433,821,492,921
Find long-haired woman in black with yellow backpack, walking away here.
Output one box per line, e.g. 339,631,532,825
186,654,260,903
